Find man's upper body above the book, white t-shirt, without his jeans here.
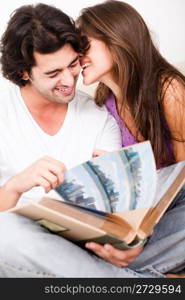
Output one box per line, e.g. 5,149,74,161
0,4,121,210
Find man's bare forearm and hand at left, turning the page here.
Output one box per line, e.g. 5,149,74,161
0,156,65,211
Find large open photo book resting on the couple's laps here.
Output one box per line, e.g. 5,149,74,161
9,141,185,249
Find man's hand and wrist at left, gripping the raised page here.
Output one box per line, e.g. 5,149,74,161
5,156,66,196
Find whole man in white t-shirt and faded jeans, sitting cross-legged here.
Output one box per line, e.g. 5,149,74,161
0,4,185,277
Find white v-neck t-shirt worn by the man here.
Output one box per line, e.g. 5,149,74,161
0,83,121,203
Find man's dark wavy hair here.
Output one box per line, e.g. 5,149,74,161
0,3,88,87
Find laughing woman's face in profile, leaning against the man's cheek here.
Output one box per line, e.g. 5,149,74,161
80,38,114,85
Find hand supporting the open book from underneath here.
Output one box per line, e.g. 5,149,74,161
85,242,143,267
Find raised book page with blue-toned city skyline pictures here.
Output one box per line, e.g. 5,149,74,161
56,141,156,212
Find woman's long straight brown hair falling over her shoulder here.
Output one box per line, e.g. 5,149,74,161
77,0,185,166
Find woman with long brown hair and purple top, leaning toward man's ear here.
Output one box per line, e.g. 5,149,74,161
77,0,185,273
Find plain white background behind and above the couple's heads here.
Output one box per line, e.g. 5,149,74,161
0,0,185,94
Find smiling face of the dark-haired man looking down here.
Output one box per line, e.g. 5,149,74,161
23,44,80,104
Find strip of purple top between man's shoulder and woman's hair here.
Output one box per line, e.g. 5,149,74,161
105,94,137,147
